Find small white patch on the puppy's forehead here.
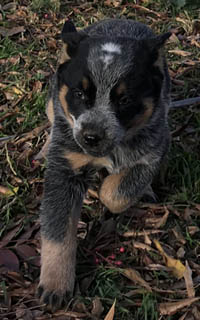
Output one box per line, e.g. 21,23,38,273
100,42,121,68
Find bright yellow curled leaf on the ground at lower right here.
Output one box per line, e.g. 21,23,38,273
154,240,186,279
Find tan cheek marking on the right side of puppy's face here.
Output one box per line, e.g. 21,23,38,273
126,97,154,138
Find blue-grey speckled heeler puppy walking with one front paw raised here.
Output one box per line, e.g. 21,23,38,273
38,19,170,310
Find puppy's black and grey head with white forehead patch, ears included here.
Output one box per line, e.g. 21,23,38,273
58,21,170,157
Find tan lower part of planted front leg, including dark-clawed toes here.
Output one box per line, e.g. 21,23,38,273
37,237,76,311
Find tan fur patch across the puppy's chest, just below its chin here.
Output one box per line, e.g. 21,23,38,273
64,152,111,170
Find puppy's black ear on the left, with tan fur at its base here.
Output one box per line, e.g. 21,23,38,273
60,20,87,63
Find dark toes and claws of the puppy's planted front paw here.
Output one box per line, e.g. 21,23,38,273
37,284,73,312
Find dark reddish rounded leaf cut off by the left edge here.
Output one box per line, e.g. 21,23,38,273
0,249,19,272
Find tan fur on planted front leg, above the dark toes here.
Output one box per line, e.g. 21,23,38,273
39,214,78,294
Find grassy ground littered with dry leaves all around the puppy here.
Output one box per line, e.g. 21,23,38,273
0,0,200,320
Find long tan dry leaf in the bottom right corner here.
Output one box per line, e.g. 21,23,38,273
159,297,200,315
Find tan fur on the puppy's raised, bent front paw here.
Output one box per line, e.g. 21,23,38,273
99,170,131,213
